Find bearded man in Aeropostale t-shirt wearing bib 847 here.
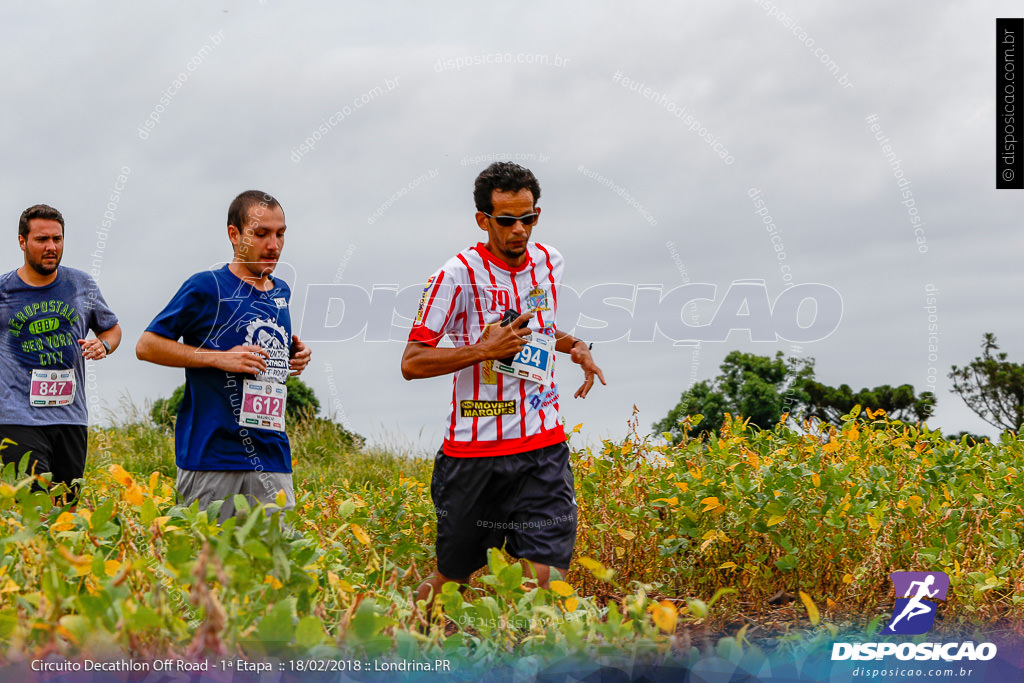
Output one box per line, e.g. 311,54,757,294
0,204,121,504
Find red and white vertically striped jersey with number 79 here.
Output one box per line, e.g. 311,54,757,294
409,243,565,458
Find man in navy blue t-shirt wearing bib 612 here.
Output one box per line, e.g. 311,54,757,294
135,190,310,520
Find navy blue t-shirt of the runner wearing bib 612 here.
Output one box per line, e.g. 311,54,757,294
146,265,292,472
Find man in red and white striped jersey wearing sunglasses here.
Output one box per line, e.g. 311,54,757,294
401,162,605,603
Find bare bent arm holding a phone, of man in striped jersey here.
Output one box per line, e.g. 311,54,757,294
401,313,532,380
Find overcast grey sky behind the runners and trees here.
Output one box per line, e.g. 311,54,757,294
0,0,1024,453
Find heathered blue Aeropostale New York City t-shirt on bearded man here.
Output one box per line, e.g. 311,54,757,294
0,266,118,427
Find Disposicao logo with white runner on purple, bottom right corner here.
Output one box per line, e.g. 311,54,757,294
831,571,996,661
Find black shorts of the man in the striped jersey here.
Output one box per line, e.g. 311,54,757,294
430,441,577,579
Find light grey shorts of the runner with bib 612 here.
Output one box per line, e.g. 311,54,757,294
177,467,295,521
